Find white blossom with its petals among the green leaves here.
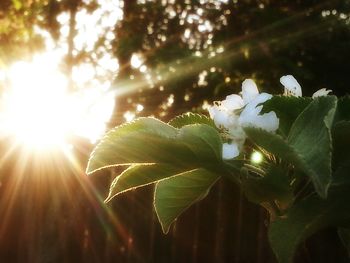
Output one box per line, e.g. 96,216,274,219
208,75,331,160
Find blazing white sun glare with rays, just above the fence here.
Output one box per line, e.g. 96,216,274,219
0,52,114,151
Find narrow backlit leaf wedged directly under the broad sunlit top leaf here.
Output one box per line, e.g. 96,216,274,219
105,164,189,202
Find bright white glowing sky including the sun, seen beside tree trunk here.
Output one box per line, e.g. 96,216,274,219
0,0,122,149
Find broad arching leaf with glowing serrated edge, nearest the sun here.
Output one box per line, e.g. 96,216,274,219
87,118,222,173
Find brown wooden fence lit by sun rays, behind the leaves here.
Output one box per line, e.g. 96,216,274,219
0,139,347,263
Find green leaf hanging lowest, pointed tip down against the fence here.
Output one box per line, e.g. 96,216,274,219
154,169,219,233
